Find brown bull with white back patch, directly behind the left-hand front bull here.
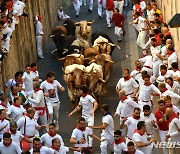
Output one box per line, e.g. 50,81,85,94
59,54,84,68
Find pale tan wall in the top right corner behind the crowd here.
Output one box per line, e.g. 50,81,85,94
156,0,180,61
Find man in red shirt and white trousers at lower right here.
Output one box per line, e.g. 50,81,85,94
154,99,169,154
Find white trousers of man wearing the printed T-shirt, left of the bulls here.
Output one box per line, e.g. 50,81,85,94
47,102,60,124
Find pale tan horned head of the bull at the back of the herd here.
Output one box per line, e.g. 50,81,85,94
75,21,93,40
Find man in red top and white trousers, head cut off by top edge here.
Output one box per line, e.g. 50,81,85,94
106,0,114,28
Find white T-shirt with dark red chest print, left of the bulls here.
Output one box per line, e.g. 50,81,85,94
40,80,62,103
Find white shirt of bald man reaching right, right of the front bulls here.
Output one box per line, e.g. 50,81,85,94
116,98,139,117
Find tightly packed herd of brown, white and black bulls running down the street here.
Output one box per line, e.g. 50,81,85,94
50,19,120,104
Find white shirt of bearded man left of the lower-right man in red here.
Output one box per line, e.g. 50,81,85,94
140,112,156,135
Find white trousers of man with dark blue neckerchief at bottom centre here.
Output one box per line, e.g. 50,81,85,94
100,136,114,154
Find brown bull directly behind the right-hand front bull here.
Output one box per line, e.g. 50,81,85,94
91,54,114,80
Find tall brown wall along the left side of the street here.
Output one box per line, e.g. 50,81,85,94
0,0,71,88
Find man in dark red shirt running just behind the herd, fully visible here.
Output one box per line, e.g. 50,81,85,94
111,8,125,42
